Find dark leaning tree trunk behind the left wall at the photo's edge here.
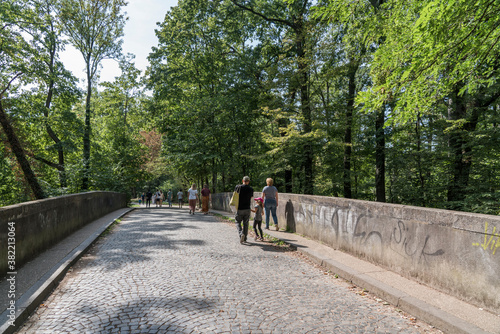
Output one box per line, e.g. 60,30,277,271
0,96,45,199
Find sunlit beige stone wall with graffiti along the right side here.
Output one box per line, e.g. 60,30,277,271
213,193,500,314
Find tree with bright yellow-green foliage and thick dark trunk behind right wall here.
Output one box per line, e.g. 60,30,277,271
363,0,500,209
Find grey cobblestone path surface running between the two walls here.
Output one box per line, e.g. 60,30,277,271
19,209,426,333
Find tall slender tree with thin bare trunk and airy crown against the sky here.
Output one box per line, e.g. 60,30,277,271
61,0,126,190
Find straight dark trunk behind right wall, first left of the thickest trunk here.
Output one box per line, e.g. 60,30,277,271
375,107,385,202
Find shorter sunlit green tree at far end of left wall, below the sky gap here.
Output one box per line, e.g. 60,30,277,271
92,55,146,192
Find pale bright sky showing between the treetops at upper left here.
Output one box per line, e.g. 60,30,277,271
60,0,177,86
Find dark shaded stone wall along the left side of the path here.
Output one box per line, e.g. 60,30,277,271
0,192,127,277
